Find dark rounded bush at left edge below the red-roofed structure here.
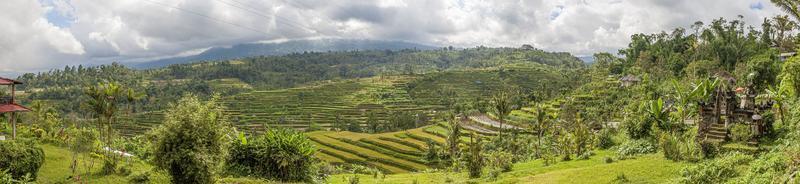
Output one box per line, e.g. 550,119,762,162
0,140,44,180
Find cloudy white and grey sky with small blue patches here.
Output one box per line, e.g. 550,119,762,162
0,0,781,75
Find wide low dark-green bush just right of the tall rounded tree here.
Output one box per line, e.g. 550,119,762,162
226,128,319,182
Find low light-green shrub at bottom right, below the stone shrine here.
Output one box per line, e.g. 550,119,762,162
680,152,753,183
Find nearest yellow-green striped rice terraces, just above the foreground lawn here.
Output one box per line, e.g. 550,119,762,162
307,124,482,173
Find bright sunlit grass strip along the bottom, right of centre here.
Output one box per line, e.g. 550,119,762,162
329,151,687,183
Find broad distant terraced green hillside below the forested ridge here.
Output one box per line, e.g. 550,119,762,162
224,66,567,132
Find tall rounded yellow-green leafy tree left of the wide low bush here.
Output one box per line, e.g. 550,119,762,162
151,96,231,183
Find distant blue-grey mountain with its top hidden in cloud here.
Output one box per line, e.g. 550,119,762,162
130,39,438,69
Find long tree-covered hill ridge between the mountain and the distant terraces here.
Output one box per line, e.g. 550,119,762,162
17,47,584,111
